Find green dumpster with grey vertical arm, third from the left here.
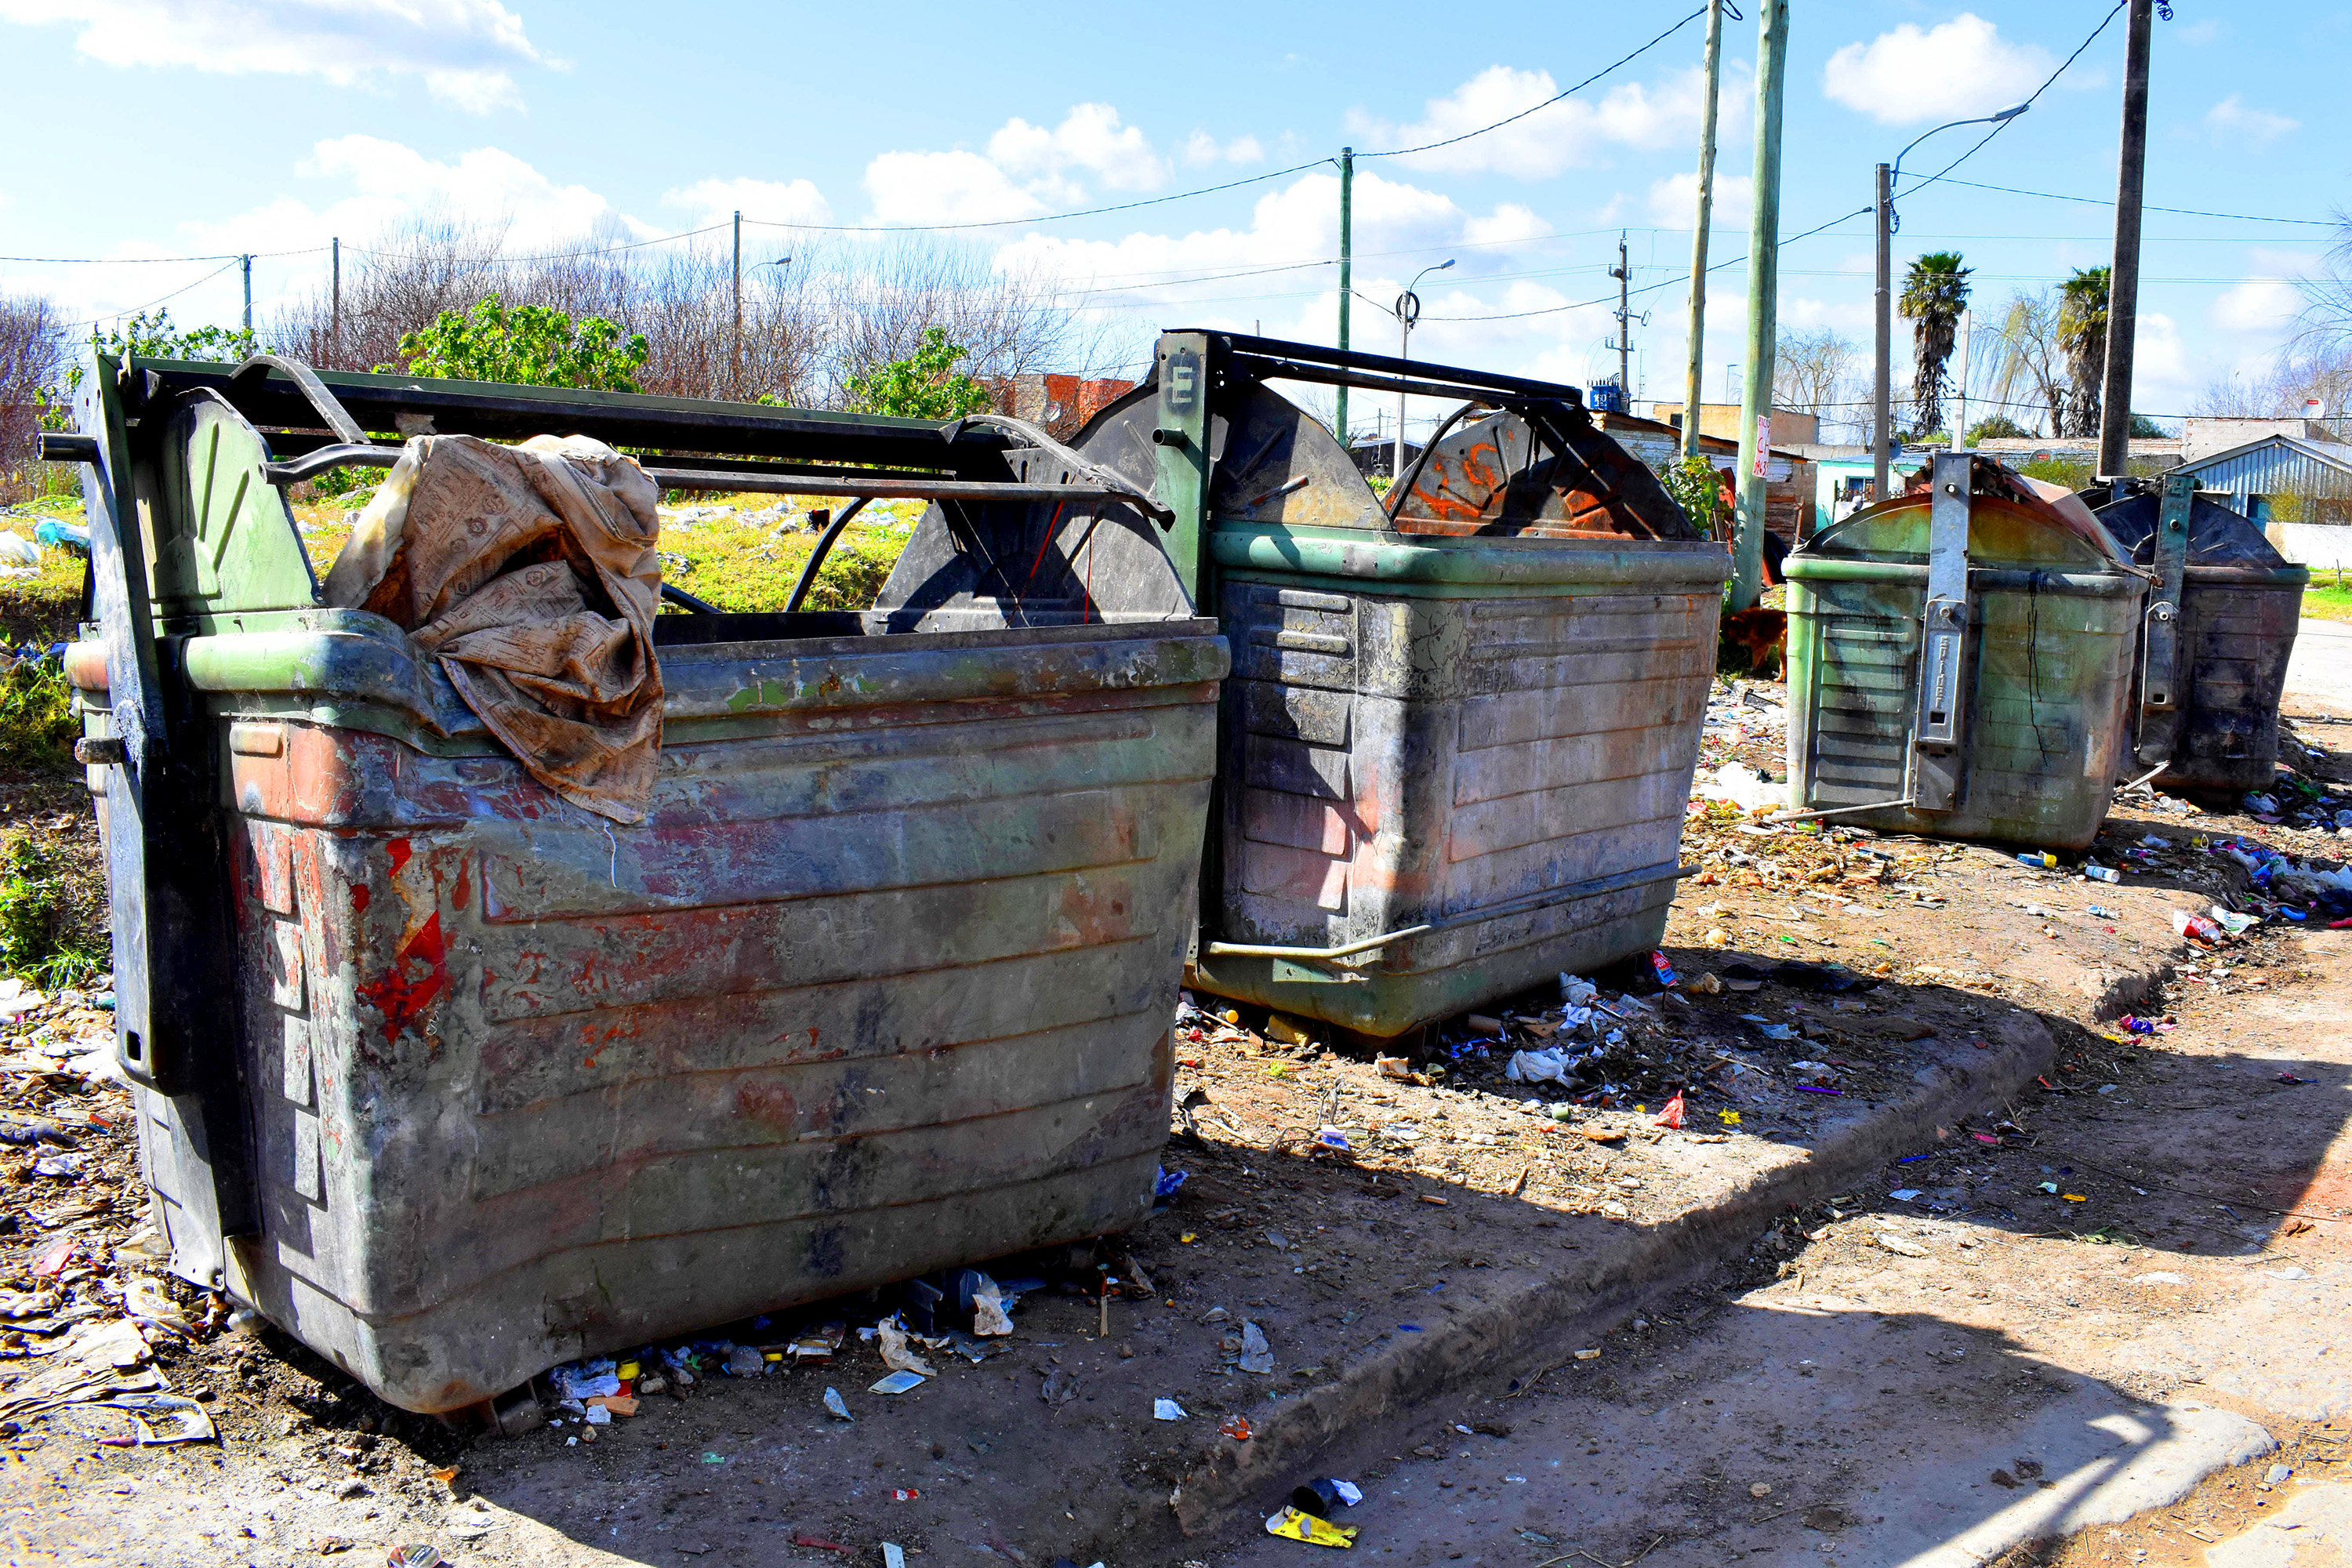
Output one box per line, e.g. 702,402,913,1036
1785,454,2147,848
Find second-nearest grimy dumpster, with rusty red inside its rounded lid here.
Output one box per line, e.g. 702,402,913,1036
882,332,1729,1039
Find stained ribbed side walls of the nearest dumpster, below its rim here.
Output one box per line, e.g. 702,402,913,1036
200,635,1216,1410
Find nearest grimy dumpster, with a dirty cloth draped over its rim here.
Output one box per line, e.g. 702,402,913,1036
52,360,1228,1410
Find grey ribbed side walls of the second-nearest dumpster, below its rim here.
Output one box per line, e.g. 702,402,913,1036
1195,572,1719,1036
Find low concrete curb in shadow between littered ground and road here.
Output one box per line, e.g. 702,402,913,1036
1162,1013,2056,1549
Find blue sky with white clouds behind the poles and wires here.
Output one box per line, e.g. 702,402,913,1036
0,0,2352,434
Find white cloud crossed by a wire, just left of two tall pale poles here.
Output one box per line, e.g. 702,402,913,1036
1355,66,1740,179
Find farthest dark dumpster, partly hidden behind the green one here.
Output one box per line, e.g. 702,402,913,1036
2084,475,2312,797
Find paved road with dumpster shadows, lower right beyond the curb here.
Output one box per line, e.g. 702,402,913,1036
1195,931,2352,1568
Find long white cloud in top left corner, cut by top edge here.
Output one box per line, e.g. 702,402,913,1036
0,0,553,115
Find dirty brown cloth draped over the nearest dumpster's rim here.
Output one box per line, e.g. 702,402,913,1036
327,435,661,822
